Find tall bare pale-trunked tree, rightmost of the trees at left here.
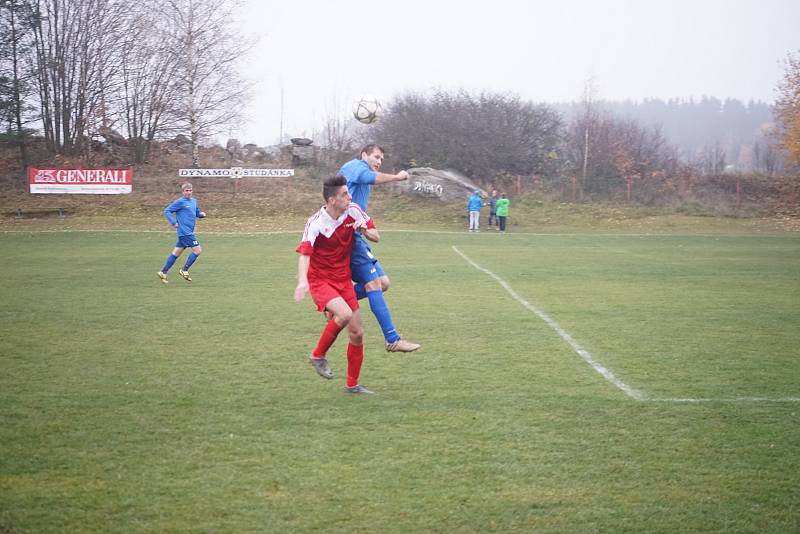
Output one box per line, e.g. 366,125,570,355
160,0,249,167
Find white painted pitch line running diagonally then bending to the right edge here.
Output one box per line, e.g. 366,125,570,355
453,245,800,404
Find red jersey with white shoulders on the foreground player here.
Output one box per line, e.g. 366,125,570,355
296,202,375,282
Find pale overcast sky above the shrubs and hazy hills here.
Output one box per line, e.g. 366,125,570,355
229,0,800,146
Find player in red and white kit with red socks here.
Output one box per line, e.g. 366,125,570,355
294,175,380,394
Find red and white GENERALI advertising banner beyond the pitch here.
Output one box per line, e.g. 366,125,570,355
28,167,133,195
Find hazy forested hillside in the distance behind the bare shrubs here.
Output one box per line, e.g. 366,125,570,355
552,96,773,169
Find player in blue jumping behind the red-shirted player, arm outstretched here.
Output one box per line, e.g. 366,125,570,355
339,144,420,352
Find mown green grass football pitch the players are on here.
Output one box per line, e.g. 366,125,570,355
0,232,800,533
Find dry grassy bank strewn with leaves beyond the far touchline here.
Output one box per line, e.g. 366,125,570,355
0,169,800,234
